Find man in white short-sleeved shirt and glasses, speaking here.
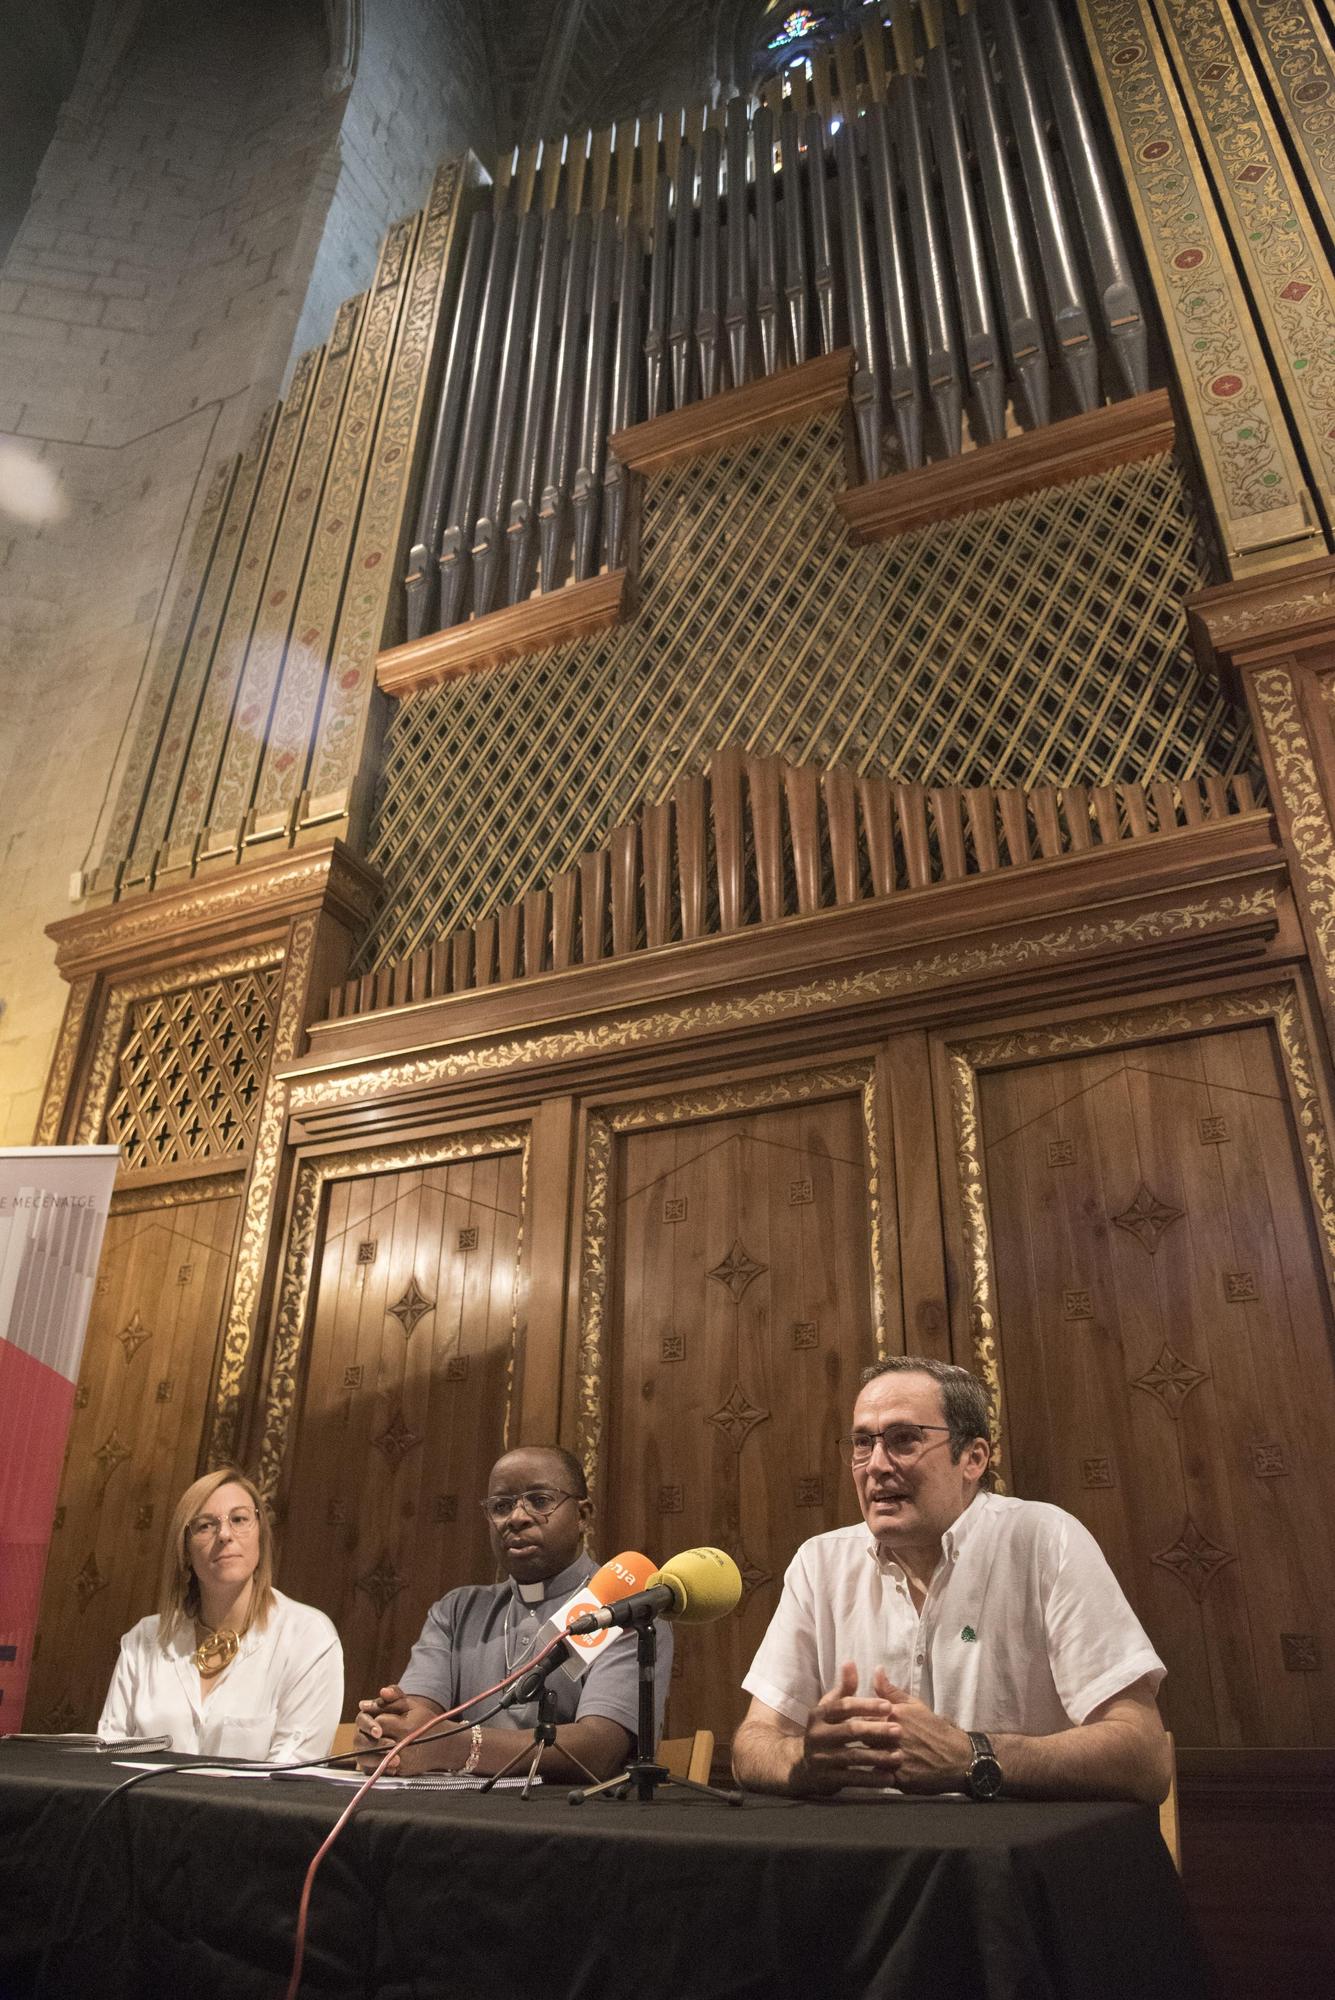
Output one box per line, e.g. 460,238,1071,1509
733,1356,1171,1804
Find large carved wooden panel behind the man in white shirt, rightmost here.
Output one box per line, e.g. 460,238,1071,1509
979,1024,1335,1744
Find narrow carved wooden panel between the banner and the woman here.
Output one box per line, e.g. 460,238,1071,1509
28,1194,240,1730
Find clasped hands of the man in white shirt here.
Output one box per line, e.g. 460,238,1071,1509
795,1662,971,1792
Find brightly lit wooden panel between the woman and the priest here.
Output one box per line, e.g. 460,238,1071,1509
278,1154,522,1712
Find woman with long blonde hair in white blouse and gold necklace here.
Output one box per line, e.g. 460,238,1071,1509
98,1466,344,1764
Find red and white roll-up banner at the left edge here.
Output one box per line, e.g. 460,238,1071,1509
0,1146,120,1736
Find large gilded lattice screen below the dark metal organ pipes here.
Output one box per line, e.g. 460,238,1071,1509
364,416,1251,964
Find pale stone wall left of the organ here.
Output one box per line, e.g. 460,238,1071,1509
0,0,490,1144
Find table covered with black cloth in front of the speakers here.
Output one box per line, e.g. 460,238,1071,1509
0,1742,1207,2000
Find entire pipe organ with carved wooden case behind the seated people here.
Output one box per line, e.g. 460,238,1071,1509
30,19,1335,1936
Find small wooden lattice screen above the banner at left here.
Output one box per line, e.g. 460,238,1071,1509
106,966,282,1168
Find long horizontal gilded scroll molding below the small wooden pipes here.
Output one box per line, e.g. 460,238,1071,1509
292,884,1275,1114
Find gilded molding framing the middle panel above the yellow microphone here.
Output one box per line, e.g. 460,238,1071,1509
576,1062,889,1500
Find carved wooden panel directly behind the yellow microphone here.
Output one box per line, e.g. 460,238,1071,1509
606,1098,873,1740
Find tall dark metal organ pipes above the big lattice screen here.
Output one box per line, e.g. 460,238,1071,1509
406,0,1151,638
